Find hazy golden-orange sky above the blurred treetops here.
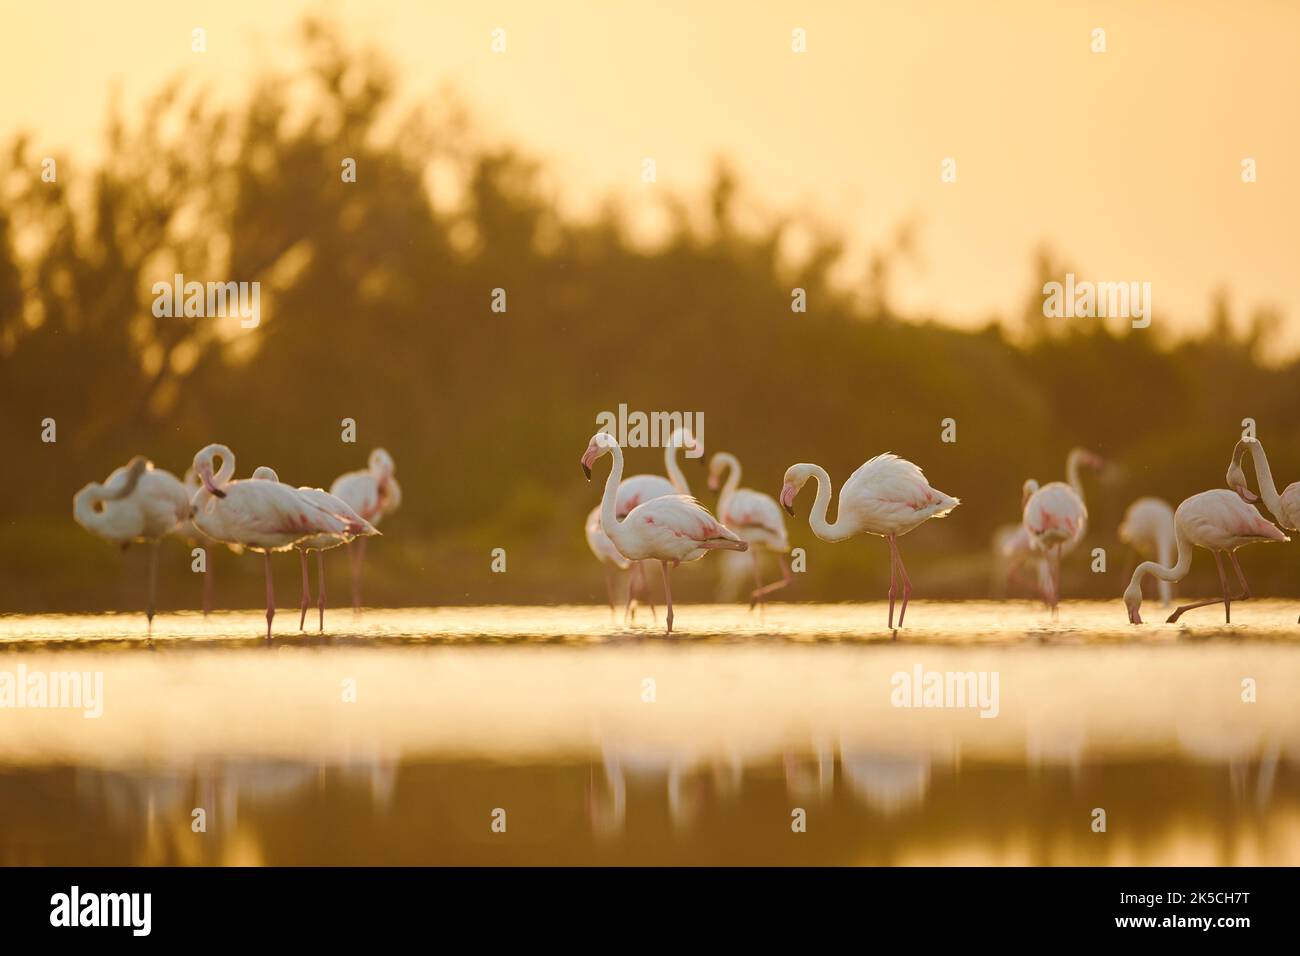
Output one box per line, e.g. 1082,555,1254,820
0,0,1300,352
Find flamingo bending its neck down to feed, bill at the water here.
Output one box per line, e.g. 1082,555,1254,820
1125,488,1291,624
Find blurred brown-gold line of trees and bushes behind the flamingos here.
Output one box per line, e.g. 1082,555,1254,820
0,21,1300,611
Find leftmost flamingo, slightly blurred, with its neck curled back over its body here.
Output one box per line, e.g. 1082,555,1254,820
73,455,190,633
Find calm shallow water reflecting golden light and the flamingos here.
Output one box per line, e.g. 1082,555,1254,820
0,601,1300,865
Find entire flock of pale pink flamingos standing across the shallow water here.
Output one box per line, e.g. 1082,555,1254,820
73,429,1300,640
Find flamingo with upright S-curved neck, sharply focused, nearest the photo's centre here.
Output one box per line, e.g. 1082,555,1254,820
582,432,749,635
